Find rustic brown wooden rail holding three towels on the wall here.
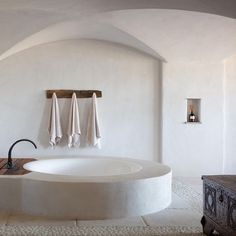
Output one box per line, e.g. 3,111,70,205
46,90,102,98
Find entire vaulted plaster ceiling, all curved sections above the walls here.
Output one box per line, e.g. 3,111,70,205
0,0,236,61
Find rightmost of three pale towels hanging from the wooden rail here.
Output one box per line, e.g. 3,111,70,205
87,93,101,148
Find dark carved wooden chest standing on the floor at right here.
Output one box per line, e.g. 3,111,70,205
201,175,236,236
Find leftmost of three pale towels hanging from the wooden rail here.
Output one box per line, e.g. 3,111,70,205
48,93,62,147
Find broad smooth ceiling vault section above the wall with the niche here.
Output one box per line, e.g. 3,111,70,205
111,10,236,62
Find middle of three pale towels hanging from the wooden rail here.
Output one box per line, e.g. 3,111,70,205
67,93,81,148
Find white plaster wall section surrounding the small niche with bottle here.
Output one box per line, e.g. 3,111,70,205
163,62,223,176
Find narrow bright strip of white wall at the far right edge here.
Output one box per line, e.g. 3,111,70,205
224,56,236,174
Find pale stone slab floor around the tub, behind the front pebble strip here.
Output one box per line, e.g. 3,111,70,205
0,177,202,230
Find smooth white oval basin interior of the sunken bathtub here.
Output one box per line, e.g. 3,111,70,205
24,158,142,177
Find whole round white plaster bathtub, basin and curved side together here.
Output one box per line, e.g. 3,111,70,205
18,157,171,220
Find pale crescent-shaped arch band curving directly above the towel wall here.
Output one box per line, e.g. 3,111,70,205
0,19,166,62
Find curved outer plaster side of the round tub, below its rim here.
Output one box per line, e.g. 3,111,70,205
22,178,171,220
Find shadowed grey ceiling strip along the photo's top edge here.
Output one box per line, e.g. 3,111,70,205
0,0,236,18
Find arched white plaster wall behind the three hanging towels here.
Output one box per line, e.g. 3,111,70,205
0,40,161,160
